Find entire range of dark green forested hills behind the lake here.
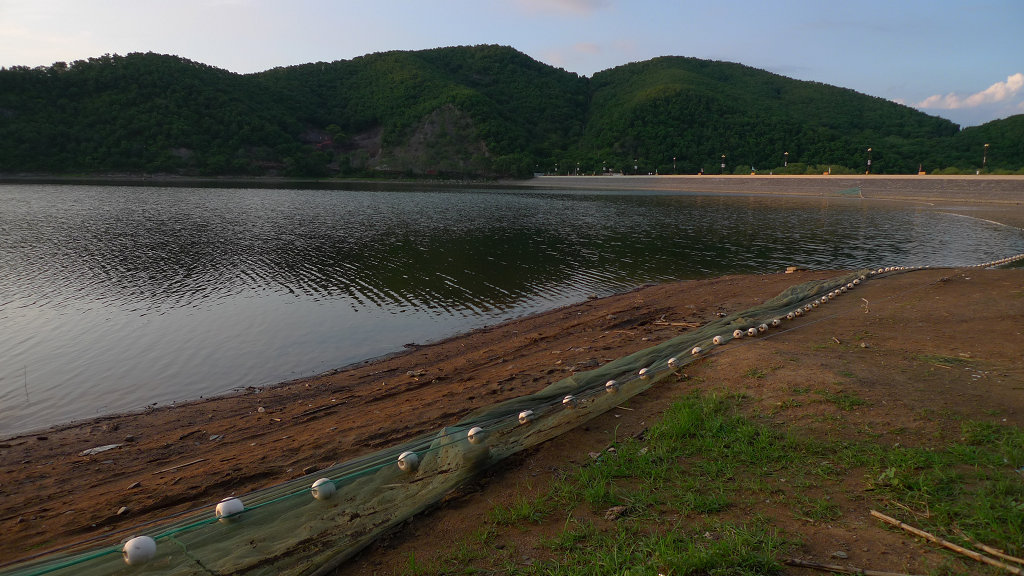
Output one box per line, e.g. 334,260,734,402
0,46,1024,176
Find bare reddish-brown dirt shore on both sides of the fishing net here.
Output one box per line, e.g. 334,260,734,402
0,177,1024,575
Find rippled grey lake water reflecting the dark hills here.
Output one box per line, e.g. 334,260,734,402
0,184,1024,437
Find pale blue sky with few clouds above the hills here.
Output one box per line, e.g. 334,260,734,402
0,0,1024,127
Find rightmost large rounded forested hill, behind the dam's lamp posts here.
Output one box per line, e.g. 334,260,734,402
580,57,957,173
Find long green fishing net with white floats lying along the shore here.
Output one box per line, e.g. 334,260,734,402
0,262,1015,576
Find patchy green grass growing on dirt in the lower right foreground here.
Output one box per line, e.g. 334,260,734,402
409,392,1024,576
